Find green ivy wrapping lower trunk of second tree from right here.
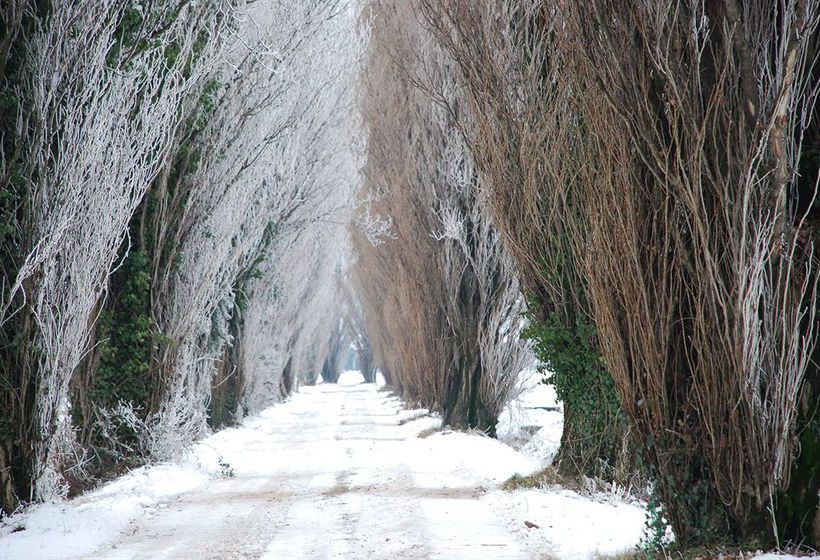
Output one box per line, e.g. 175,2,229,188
524,306,626,476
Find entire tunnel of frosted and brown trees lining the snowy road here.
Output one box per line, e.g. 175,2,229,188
0,0,820,546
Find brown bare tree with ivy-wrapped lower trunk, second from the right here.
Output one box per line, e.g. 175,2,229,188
416,0,634,480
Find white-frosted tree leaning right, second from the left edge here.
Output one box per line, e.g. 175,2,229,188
139,1,359,456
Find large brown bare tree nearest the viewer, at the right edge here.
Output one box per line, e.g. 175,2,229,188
555,0,820,543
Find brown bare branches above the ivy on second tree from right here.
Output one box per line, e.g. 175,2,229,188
418,0,583,321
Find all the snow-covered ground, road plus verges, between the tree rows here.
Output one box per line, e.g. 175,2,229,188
0,373,644,560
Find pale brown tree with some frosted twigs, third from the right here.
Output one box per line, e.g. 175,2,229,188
354,2,528,432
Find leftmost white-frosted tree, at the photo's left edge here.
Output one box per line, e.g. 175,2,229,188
0,0,227,509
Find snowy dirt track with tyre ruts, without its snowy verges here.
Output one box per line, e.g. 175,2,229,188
93,385,529,560
